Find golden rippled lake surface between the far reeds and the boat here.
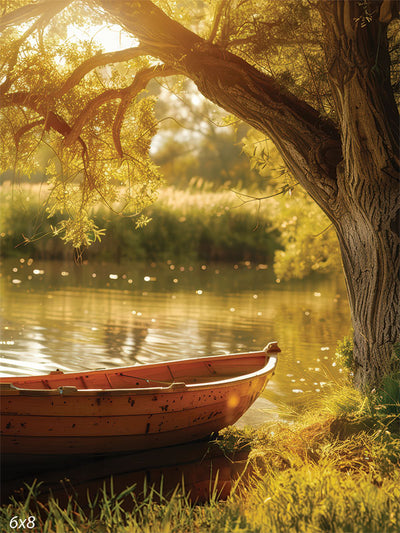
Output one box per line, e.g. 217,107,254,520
0,257,350,423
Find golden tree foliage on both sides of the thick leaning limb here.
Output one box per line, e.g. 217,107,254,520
0,0,399,247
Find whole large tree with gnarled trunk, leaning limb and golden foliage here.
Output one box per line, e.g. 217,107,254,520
0,0,400,386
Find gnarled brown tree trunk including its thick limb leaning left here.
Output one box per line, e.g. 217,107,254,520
99,0,400,389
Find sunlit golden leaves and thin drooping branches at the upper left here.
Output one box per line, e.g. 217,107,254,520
1,3,170,247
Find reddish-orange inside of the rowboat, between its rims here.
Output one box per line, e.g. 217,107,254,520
0,351,269,390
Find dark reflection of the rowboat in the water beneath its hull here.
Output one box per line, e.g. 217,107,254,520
1,439,249,509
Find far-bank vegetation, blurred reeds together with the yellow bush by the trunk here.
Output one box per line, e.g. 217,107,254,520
0,179,340,279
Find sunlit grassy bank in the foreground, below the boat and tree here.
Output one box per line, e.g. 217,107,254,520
1,387,400,533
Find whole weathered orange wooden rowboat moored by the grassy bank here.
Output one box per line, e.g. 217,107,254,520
0,342,280,457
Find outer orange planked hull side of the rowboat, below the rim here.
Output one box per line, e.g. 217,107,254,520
1,348,275,456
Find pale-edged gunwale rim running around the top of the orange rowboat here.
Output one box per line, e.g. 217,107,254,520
0,352,280,397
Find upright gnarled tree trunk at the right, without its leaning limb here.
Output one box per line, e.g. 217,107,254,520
323,0,400,389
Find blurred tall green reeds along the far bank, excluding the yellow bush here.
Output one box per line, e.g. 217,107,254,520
0,183,278,262
